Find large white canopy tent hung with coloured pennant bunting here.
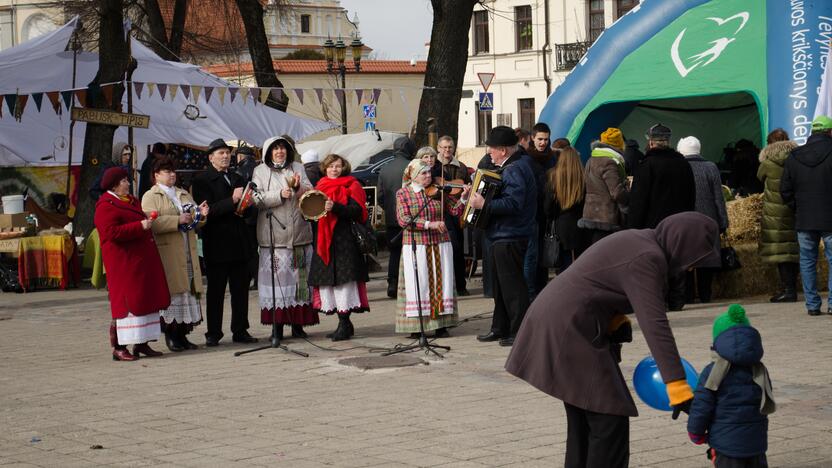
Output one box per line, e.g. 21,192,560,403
0,19,337,166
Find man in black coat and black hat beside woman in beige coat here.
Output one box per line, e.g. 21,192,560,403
193,139,257,346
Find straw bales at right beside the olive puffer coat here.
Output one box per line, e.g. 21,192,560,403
713,241,829,299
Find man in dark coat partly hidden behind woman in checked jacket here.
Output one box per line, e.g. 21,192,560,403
378,137,416,299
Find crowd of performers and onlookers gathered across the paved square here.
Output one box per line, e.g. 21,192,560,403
95,117,832,467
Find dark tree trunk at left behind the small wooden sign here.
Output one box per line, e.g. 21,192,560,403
73,0,130,236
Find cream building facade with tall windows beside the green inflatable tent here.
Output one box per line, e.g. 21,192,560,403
457,0,638,156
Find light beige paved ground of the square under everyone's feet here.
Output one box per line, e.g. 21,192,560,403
0,266,832,468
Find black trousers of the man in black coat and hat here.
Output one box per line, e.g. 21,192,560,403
205,260,251,339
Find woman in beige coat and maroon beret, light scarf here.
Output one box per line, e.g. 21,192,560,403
142,156,208,352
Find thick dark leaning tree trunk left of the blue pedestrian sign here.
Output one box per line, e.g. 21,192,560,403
414,0,479,146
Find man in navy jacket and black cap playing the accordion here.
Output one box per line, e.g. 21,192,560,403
464,125,537,346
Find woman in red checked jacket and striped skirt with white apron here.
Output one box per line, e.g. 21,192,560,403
396,159,467,339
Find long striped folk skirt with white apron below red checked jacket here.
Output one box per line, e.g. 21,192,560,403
396,242,459,333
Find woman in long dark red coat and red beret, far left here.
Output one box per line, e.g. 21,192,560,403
95,167,170,361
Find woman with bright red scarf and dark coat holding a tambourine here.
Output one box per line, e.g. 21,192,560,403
309,154,370,341
